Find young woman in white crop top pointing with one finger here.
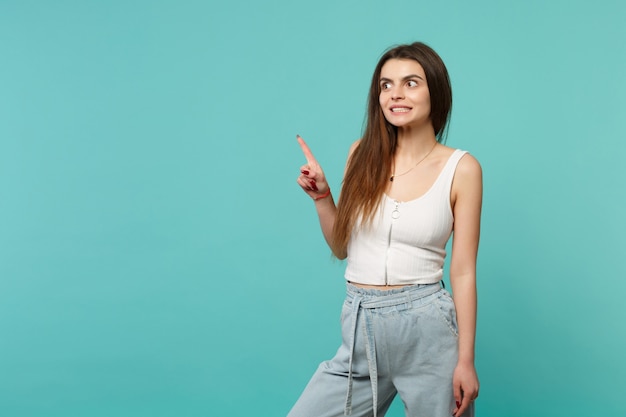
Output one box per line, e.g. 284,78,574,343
289,42,482,417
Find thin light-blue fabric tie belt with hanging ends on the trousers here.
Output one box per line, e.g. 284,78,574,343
344,283,441,417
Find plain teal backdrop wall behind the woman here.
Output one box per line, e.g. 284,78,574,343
0,0,626,417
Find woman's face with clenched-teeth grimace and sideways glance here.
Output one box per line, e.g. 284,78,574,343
378,59,432,127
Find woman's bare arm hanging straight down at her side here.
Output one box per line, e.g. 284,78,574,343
450,155,483,417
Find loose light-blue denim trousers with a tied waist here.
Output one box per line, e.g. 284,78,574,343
288,283,474,417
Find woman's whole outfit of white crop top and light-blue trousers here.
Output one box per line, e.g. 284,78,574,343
288,150,474,417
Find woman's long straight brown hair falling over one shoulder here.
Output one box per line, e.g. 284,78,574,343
332,42,452,257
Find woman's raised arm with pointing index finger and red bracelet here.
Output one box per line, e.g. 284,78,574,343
297,136,358,259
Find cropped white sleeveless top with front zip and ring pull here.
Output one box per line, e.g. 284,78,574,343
345,149,467,285
